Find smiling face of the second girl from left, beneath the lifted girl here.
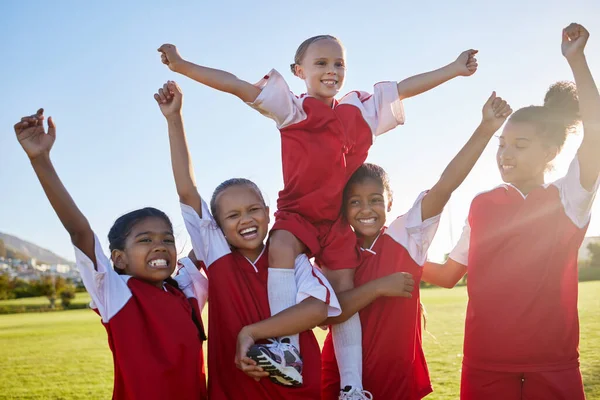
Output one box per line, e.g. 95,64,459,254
215,184,269,261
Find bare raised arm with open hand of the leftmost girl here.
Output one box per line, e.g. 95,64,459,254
15,108,96,265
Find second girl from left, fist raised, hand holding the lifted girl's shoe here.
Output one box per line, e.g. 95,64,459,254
155,82,340,400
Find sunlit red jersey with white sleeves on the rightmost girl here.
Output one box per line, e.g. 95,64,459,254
450,158,598,372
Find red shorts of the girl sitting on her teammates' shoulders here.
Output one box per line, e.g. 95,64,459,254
271,211,360,270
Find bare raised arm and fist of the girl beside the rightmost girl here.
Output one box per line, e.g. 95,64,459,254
421,92,512,221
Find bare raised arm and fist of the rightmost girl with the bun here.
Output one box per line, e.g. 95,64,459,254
561,23,600,190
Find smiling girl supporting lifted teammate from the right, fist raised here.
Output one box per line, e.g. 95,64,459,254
322,93,512,400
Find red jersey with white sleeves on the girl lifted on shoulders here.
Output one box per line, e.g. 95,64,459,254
251,70,404,223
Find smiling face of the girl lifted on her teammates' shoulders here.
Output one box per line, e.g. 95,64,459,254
296,39,346,105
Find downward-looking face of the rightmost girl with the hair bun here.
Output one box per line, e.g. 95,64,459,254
496,121,558,194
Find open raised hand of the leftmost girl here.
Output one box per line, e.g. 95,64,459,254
15,108,56,160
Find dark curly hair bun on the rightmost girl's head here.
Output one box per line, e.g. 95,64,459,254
544,81,580,129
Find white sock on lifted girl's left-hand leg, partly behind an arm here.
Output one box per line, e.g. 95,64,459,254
267,268,300,351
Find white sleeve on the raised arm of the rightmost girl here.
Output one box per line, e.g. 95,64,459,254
553,156,600,228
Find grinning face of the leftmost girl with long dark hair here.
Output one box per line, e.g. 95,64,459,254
112,217,177,287
